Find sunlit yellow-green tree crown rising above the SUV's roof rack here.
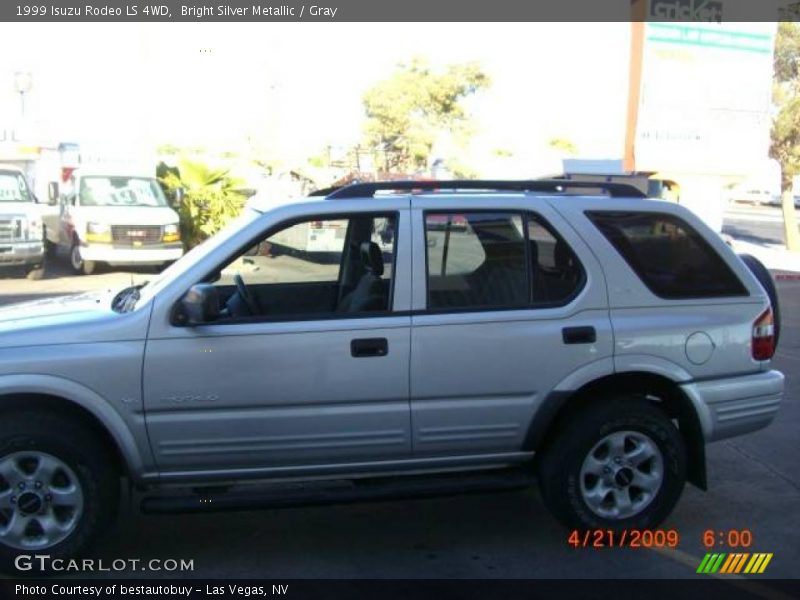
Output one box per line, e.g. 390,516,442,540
364,59,489,173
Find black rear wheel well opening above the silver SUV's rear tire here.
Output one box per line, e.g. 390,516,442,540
524,371,707,490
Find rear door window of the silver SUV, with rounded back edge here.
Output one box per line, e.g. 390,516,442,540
425,212,584,310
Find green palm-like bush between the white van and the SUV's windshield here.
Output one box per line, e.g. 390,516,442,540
157,159,247,248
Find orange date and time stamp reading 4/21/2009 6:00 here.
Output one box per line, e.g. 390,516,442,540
567,529,753,549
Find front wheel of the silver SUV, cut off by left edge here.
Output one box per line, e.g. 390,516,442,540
0,411,120,574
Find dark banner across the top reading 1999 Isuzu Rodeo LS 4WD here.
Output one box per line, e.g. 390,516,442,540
0,0,800,23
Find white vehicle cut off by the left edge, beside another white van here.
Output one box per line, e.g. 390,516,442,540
0,164,44,279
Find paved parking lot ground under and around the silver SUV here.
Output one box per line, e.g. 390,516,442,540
0,255,800,581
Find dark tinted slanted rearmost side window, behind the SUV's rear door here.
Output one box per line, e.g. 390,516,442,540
586,211,747,299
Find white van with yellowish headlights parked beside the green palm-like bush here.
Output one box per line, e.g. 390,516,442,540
45,167,183,275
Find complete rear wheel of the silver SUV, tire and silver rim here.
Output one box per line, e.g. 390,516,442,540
539,396,686,530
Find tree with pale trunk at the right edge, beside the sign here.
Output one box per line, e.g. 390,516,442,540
770,22,800,252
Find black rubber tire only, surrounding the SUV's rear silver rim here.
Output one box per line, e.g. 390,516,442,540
538,396,686,530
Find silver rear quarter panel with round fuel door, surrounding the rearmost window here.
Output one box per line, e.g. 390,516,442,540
554,198,769,381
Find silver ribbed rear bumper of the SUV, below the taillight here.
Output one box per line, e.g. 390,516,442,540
681,371,783,442
